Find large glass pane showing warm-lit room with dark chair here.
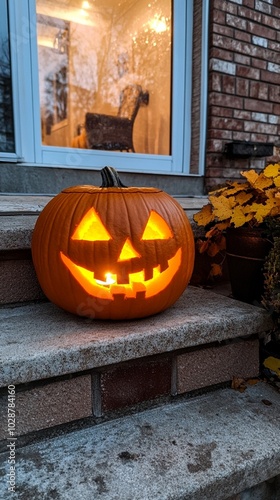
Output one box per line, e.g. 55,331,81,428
36,0,172,155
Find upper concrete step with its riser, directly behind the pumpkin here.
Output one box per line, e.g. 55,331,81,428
0,194,207,304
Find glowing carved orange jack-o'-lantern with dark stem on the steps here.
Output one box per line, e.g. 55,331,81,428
32,167,194,319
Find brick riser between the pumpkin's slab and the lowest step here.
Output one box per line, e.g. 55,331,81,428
0,339,259,440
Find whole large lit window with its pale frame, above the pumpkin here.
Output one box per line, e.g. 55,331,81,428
3,0,208,175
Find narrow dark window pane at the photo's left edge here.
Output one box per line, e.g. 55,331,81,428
0,0,15,153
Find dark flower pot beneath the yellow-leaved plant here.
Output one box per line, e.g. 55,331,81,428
226,227,272,304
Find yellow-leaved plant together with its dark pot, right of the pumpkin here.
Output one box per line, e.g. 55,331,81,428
194,164,280,303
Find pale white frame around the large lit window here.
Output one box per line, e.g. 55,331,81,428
3,0,209,175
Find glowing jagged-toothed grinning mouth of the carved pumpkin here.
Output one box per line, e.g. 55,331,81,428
60,248,182,300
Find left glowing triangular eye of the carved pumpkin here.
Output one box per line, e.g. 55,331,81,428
71,208,112,241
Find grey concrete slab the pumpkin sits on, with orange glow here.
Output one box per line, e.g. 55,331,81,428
0,287,272,387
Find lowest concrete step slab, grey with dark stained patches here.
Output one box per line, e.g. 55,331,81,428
0,382,280,500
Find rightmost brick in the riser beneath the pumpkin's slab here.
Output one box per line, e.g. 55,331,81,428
177,340,259,394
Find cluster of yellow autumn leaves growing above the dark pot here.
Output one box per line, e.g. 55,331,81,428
193,164,280,275
